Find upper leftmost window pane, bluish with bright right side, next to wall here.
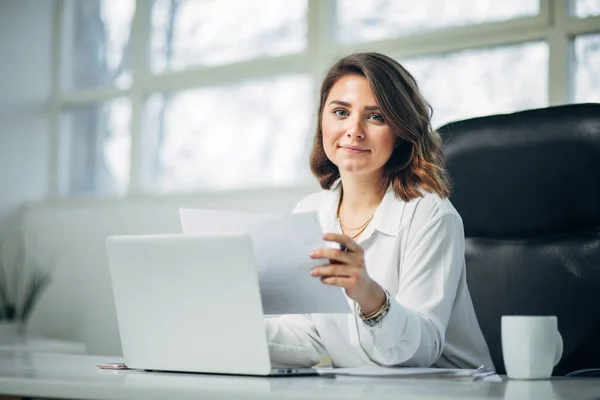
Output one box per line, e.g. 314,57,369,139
63,0,135,90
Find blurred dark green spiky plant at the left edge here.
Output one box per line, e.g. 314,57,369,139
0,239,50,323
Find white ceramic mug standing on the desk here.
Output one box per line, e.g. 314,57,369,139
502,315,563,379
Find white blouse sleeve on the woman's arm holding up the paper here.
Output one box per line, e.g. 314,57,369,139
357,208,465,367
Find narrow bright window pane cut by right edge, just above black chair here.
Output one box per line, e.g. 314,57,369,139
572,33,600,103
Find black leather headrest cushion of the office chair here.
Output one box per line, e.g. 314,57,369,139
439,103,600,237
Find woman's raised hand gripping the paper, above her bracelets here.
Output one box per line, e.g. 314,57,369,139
310,233,385,314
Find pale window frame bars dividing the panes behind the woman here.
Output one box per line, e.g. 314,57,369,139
48,0,600,199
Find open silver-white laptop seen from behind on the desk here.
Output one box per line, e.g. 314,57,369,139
106,233,316,376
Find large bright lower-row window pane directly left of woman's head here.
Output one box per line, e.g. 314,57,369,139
145,75,312,191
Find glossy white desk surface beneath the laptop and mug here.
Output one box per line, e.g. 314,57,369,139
0,350,600,400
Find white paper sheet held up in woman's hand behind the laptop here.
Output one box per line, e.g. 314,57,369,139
179,208,351,314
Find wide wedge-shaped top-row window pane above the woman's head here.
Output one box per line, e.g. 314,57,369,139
336,0,540,43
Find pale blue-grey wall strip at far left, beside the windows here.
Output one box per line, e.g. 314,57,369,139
0,0,55,227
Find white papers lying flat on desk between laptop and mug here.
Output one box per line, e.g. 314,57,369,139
318,365,500,381
